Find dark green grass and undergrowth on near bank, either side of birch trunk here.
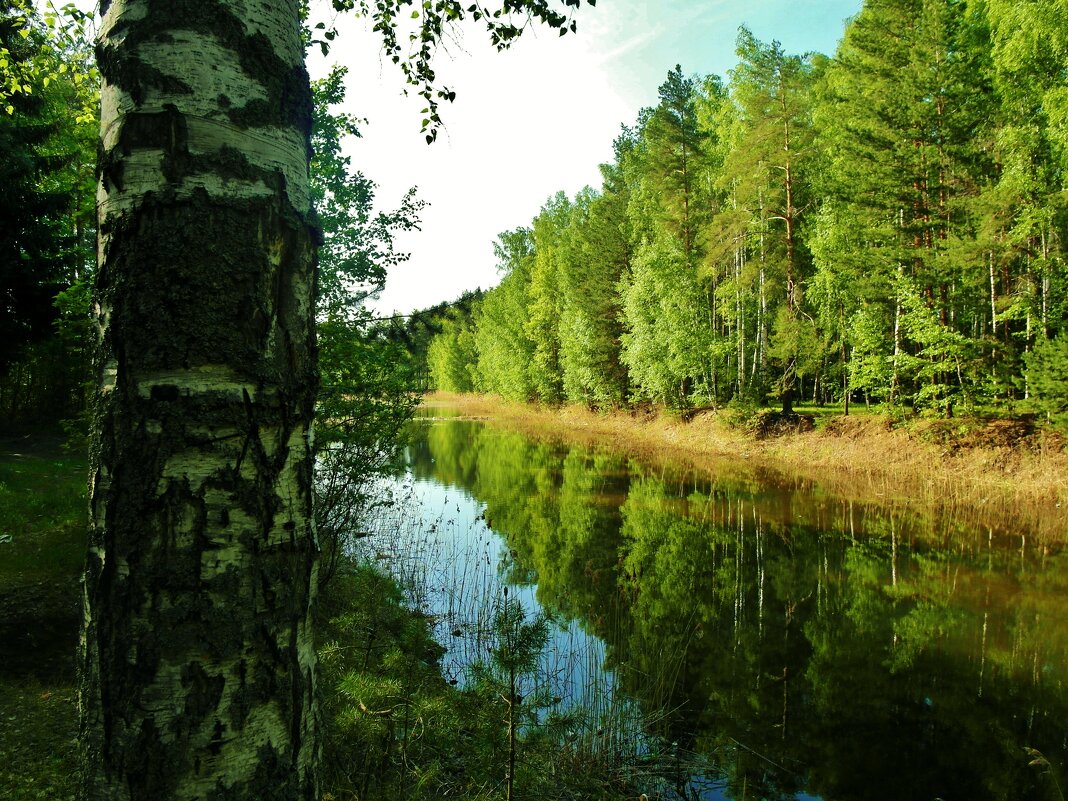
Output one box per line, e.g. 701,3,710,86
0,440,637,801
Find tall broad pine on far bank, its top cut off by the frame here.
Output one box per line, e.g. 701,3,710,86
813,0,983,410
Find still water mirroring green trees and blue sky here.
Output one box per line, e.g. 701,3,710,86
363,420,1068,801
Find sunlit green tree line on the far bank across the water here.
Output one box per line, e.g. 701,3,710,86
428,0,1068,427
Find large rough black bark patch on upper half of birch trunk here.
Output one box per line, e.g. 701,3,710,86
98,191,307,373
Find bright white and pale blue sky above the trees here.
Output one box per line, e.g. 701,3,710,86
309,0,861,314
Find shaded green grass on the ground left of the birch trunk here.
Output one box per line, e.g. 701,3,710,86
0,447,85,801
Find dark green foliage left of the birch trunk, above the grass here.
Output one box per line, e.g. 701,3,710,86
0,3,98,425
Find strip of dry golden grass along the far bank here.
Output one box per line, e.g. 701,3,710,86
423,393,1068,541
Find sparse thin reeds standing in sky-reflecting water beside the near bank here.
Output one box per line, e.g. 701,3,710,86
337,477,747,799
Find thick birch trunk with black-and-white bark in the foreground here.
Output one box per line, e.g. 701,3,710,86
81,0,318,801
